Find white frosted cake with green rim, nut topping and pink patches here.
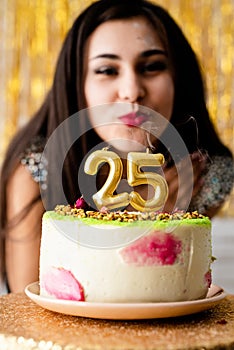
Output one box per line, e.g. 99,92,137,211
40,206,212,303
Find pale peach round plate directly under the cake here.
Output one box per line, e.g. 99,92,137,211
25,282,227,320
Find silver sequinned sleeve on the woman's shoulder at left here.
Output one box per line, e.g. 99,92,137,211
20,136,47,186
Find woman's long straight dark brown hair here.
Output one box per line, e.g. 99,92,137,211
0,0,230,280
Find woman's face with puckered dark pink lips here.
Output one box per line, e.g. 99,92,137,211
84,17,174,150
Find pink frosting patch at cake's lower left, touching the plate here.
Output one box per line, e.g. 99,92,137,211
42,267,85,301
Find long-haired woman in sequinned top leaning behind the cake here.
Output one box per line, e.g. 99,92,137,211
1,0,233,292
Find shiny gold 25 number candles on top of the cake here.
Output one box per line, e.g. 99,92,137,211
84,149,168,211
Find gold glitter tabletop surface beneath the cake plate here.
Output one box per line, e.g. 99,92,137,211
0,293,234,350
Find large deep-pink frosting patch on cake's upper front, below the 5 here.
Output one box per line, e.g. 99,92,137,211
120,231,181,266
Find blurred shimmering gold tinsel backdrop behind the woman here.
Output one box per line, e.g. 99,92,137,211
0,0,234,216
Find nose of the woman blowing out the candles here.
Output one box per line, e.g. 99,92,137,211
118,73,145,102
